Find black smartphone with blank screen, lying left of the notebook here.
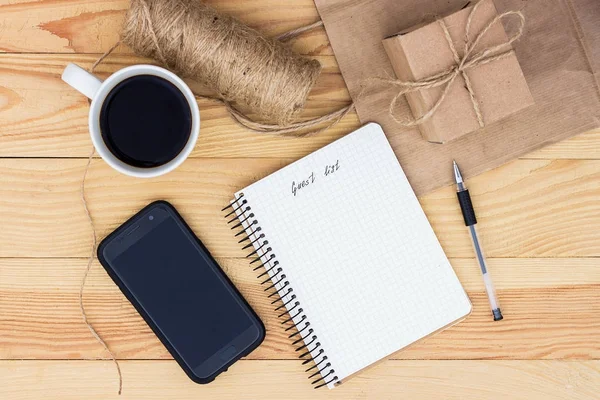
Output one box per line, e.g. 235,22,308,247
98,201,265,384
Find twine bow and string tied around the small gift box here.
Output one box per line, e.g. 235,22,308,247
377,2,525,128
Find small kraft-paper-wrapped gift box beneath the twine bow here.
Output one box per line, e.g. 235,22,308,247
383,0,533,143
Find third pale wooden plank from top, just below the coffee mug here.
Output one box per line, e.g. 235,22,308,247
0,159,600,257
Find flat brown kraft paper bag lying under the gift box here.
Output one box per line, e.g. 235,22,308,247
315,0,600,195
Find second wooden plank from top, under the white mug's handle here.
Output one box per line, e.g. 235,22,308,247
0,54,359,158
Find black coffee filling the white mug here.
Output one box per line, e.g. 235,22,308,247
100,75,192,168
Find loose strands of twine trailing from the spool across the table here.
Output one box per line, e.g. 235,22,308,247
79,14,342,395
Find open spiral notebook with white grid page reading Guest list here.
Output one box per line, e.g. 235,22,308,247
226,123,471,388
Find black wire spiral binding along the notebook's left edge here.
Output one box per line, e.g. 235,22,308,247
221,193,341,389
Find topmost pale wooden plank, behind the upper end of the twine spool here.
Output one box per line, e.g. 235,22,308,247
0,0,333,55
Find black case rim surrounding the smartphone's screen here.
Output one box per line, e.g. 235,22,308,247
97,200,266,384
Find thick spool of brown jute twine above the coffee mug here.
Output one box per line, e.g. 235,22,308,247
121,0,321,126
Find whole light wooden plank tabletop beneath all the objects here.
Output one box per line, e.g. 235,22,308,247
0,0,600,400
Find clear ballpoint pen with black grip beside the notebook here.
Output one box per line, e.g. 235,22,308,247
453,161,503,321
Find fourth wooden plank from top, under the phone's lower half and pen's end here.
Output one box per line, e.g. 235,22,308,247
0,258,600,359
